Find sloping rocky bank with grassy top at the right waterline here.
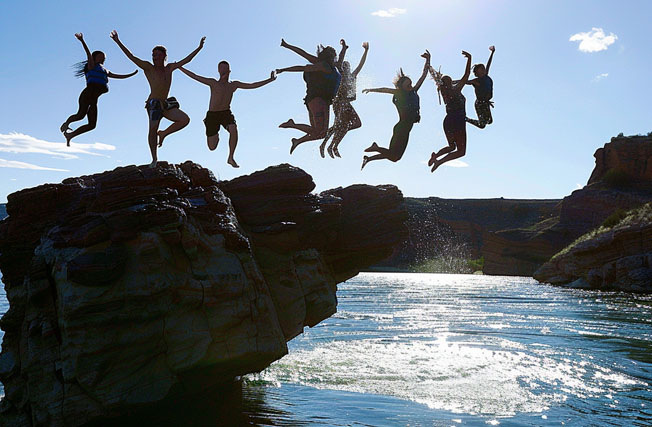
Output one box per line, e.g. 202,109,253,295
534,204,652,293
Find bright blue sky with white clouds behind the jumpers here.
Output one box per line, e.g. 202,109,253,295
0,0,652,202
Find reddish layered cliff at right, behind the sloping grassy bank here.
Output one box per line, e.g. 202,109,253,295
482,136,652,276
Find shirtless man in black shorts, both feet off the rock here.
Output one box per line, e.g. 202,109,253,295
179,61,276,168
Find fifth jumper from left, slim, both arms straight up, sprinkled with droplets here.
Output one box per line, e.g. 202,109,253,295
319,39,369,158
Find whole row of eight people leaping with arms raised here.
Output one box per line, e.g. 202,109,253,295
61,30,495,172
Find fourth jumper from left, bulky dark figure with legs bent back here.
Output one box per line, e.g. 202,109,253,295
276,39,342,154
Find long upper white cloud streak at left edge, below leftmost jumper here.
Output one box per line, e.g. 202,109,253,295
0,132,115,160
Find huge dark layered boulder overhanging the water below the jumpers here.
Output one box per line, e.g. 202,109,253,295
0,162,406,426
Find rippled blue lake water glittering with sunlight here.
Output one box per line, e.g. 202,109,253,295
0,273,652,426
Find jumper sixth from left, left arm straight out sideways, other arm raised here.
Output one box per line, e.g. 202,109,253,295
360,50,430,170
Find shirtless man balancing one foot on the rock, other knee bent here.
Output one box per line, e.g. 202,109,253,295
111,30,206,167
